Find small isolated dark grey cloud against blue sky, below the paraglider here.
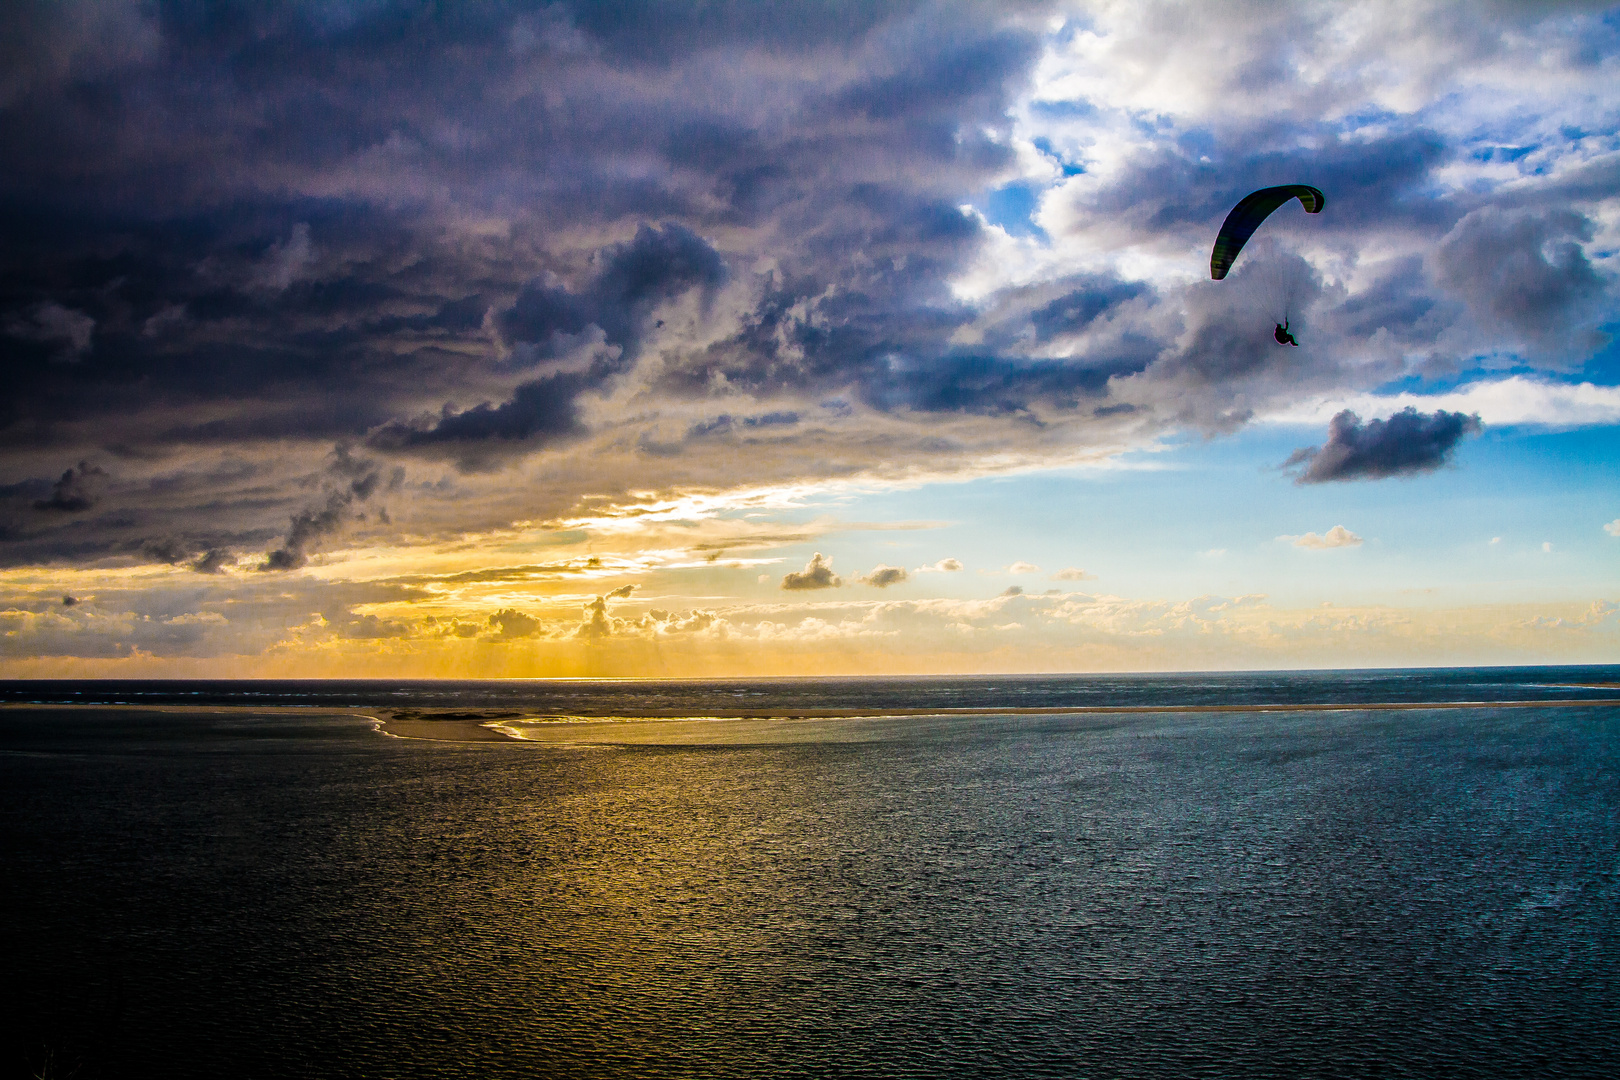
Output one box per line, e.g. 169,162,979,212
1285,408,1481,484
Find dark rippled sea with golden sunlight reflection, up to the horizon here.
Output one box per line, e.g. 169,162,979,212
0,667,1620,1080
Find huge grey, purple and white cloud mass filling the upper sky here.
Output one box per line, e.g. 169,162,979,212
0,0,1620,648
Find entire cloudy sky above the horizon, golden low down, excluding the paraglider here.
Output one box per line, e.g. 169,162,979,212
0,0,1620,678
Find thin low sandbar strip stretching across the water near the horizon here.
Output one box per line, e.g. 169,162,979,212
0,702,1620,743
